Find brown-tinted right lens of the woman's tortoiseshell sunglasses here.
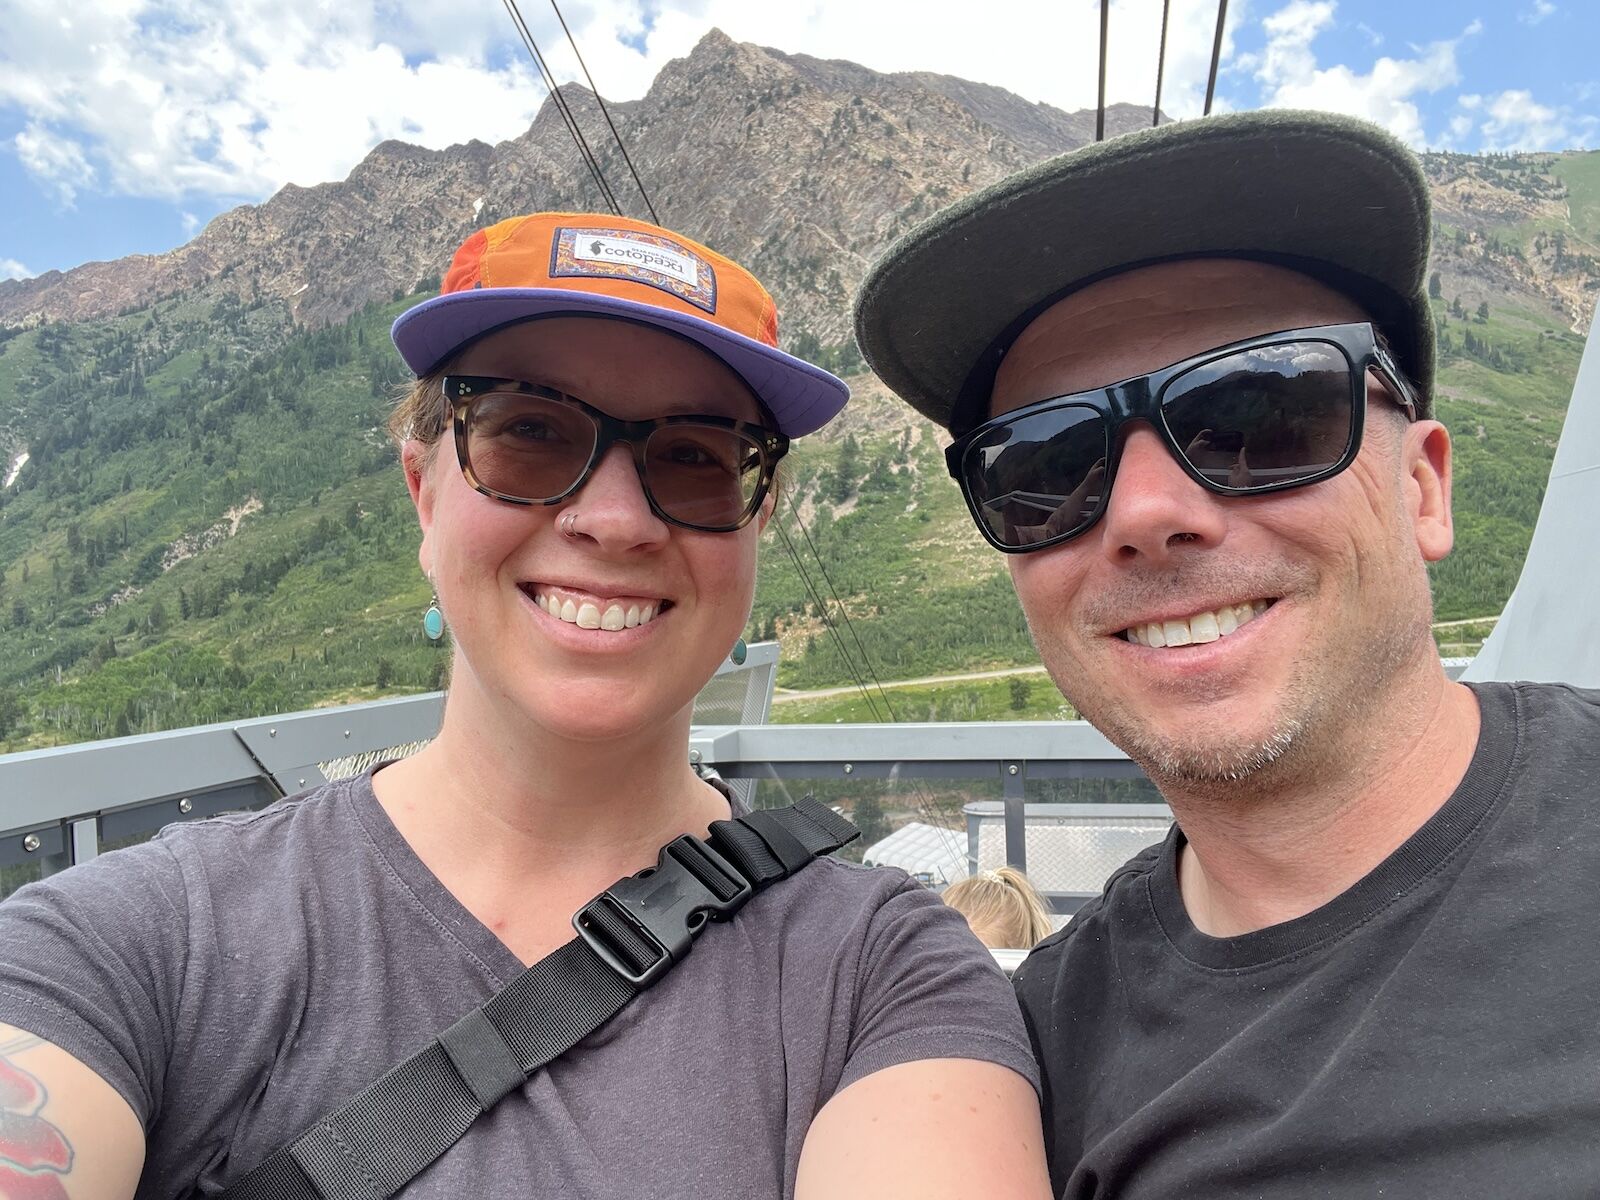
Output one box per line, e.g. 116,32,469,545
645,421,766,531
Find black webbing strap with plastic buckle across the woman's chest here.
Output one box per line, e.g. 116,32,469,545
222,797,858,1200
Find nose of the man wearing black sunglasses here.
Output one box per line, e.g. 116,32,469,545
1099,426,1227,563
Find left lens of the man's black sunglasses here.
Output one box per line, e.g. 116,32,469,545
962,405,1107,549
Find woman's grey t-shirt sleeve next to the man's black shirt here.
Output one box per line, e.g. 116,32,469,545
838,880,1038,1091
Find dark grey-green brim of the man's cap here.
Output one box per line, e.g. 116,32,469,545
856,110,1434,429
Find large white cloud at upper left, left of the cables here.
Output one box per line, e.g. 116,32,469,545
0,0,542,202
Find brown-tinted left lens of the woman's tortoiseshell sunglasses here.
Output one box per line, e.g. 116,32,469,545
467,392,597,502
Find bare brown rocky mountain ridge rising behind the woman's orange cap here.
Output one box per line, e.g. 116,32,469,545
0,30,1149,342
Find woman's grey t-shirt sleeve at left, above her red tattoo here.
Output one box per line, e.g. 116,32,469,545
0,842,189,1130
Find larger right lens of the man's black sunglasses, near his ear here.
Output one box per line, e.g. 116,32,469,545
1162,341,1357,490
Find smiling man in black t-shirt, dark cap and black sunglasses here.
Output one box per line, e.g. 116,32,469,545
856,112,1600,1200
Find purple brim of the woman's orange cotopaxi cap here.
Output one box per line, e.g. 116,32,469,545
390,288,850,437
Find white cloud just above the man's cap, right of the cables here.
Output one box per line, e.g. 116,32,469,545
1254,0,1482,146
